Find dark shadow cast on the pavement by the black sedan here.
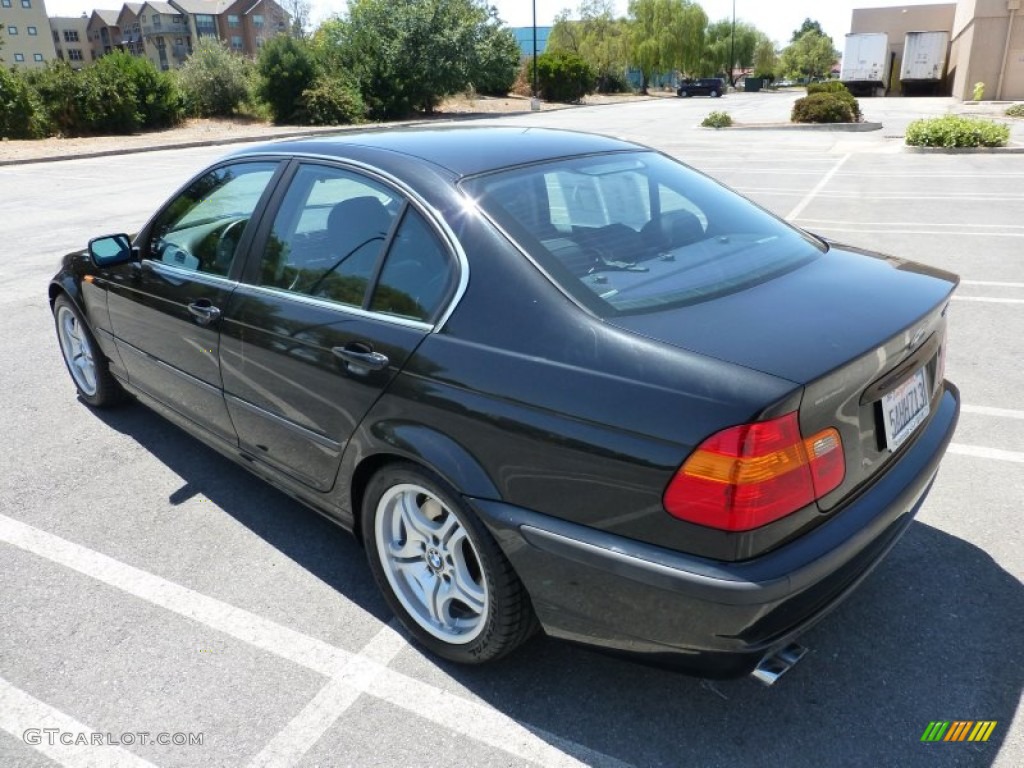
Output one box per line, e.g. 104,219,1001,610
94,407,1024,768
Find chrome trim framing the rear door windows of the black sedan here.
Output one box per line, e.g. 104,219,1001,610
232,147,469,334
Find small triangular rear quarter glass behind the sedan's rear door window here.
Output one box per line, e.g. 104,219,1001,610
370,207,456,321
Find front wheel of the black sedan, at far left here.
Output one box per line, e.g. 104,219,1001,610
53,294,125,408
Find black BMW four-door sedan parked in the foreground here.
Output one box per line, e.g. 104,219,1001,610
49,128,959,677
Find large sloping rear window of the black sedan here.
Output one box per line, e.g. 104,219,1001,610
463,152,824,314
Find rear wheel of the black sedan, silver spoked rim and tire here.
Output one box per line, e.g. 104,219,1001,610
361,462,538,664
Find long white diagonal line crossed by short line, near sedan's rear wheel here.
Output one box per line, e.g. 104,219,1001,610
0,515,628,768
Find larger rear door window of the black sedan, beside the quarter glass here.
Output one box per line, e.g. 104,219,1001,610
259,165,404,307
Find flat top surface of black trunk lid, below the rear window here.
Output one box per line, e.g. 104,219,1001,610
607,244,959,384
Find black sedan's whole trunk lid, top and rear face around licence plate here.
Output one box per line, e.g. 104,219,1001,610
608,245,958,501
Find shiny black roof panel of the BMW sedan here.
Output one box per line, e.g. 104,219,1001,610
234,126,648,176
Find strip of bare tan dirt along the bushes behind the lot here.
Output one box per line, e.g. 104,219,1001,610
0,94,674,164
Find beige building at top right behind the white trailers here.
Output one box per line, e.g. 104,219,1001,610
850,0,1024,100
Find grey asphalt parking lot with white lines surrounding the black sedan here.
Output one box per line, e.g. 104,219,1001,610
0,94,1024,768
